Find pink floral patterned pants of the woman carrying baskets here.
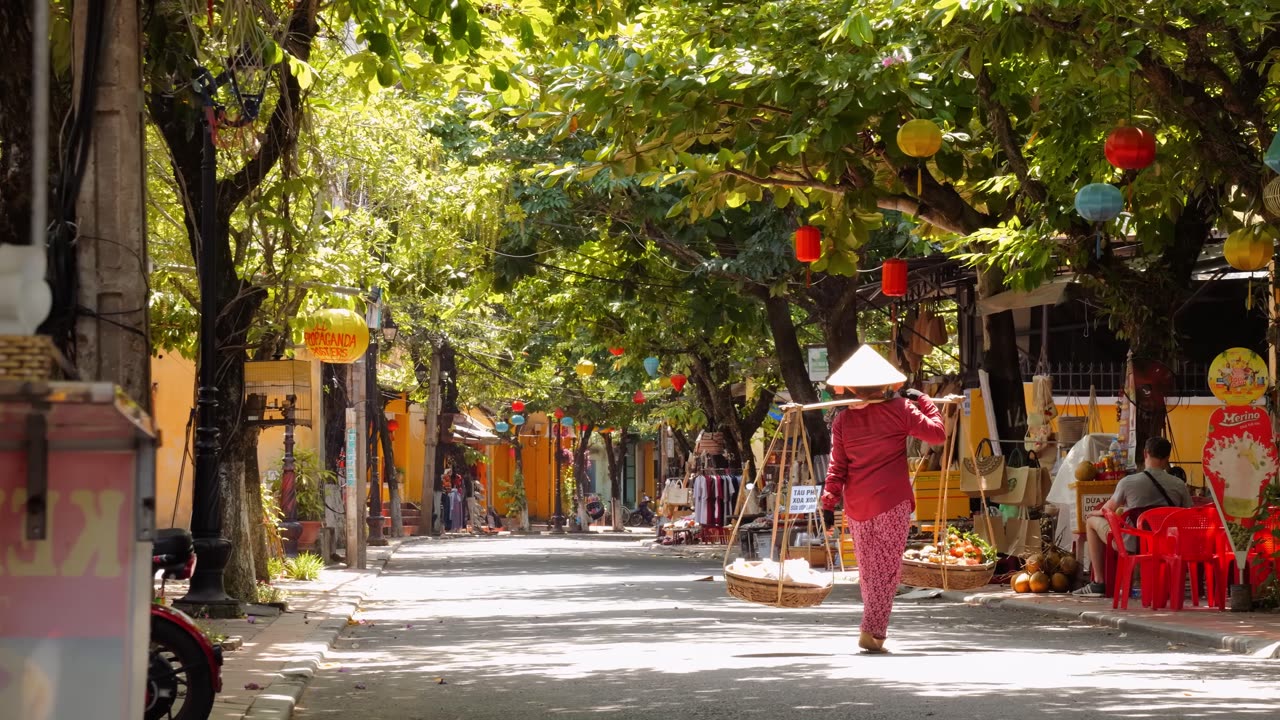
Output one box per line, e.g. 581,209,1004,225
850,501,911,638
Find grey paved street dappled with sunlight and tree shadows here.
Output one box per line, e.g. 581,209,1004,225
296,537,1280,720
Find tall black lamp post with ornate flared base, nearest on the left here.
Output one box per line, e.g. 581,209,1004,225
177,73,239,616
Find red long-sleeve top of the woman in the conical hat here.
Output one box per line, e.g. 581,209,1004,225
824,397,946,521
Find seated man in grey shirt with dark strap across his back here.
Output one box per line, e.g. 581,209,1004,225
1073,437,1192,597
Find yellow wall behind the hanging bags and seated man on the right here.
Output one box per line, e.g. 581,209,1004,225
960,383,1221,487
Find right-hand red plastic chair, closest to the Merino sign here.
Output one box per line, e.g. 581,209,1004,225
1157,507,1233,610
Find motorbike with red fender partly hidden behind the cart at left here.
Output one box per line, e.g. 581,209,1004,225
143,529,223,720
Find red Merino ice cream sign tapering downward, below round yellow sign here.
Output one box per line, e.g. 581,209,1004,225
1203,405,1280,561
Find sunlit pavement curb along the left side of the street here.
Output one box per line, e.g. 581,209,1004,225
243,538,413,720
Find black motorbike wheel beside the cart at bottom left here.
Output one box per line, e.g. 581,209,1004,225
143,615,214,720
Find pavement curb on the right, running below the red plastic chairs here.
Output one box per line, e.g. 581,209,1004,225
942,591,1280,660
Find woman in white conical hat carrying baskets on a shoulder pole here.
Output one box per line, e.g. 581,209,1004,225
823,345,946,652
